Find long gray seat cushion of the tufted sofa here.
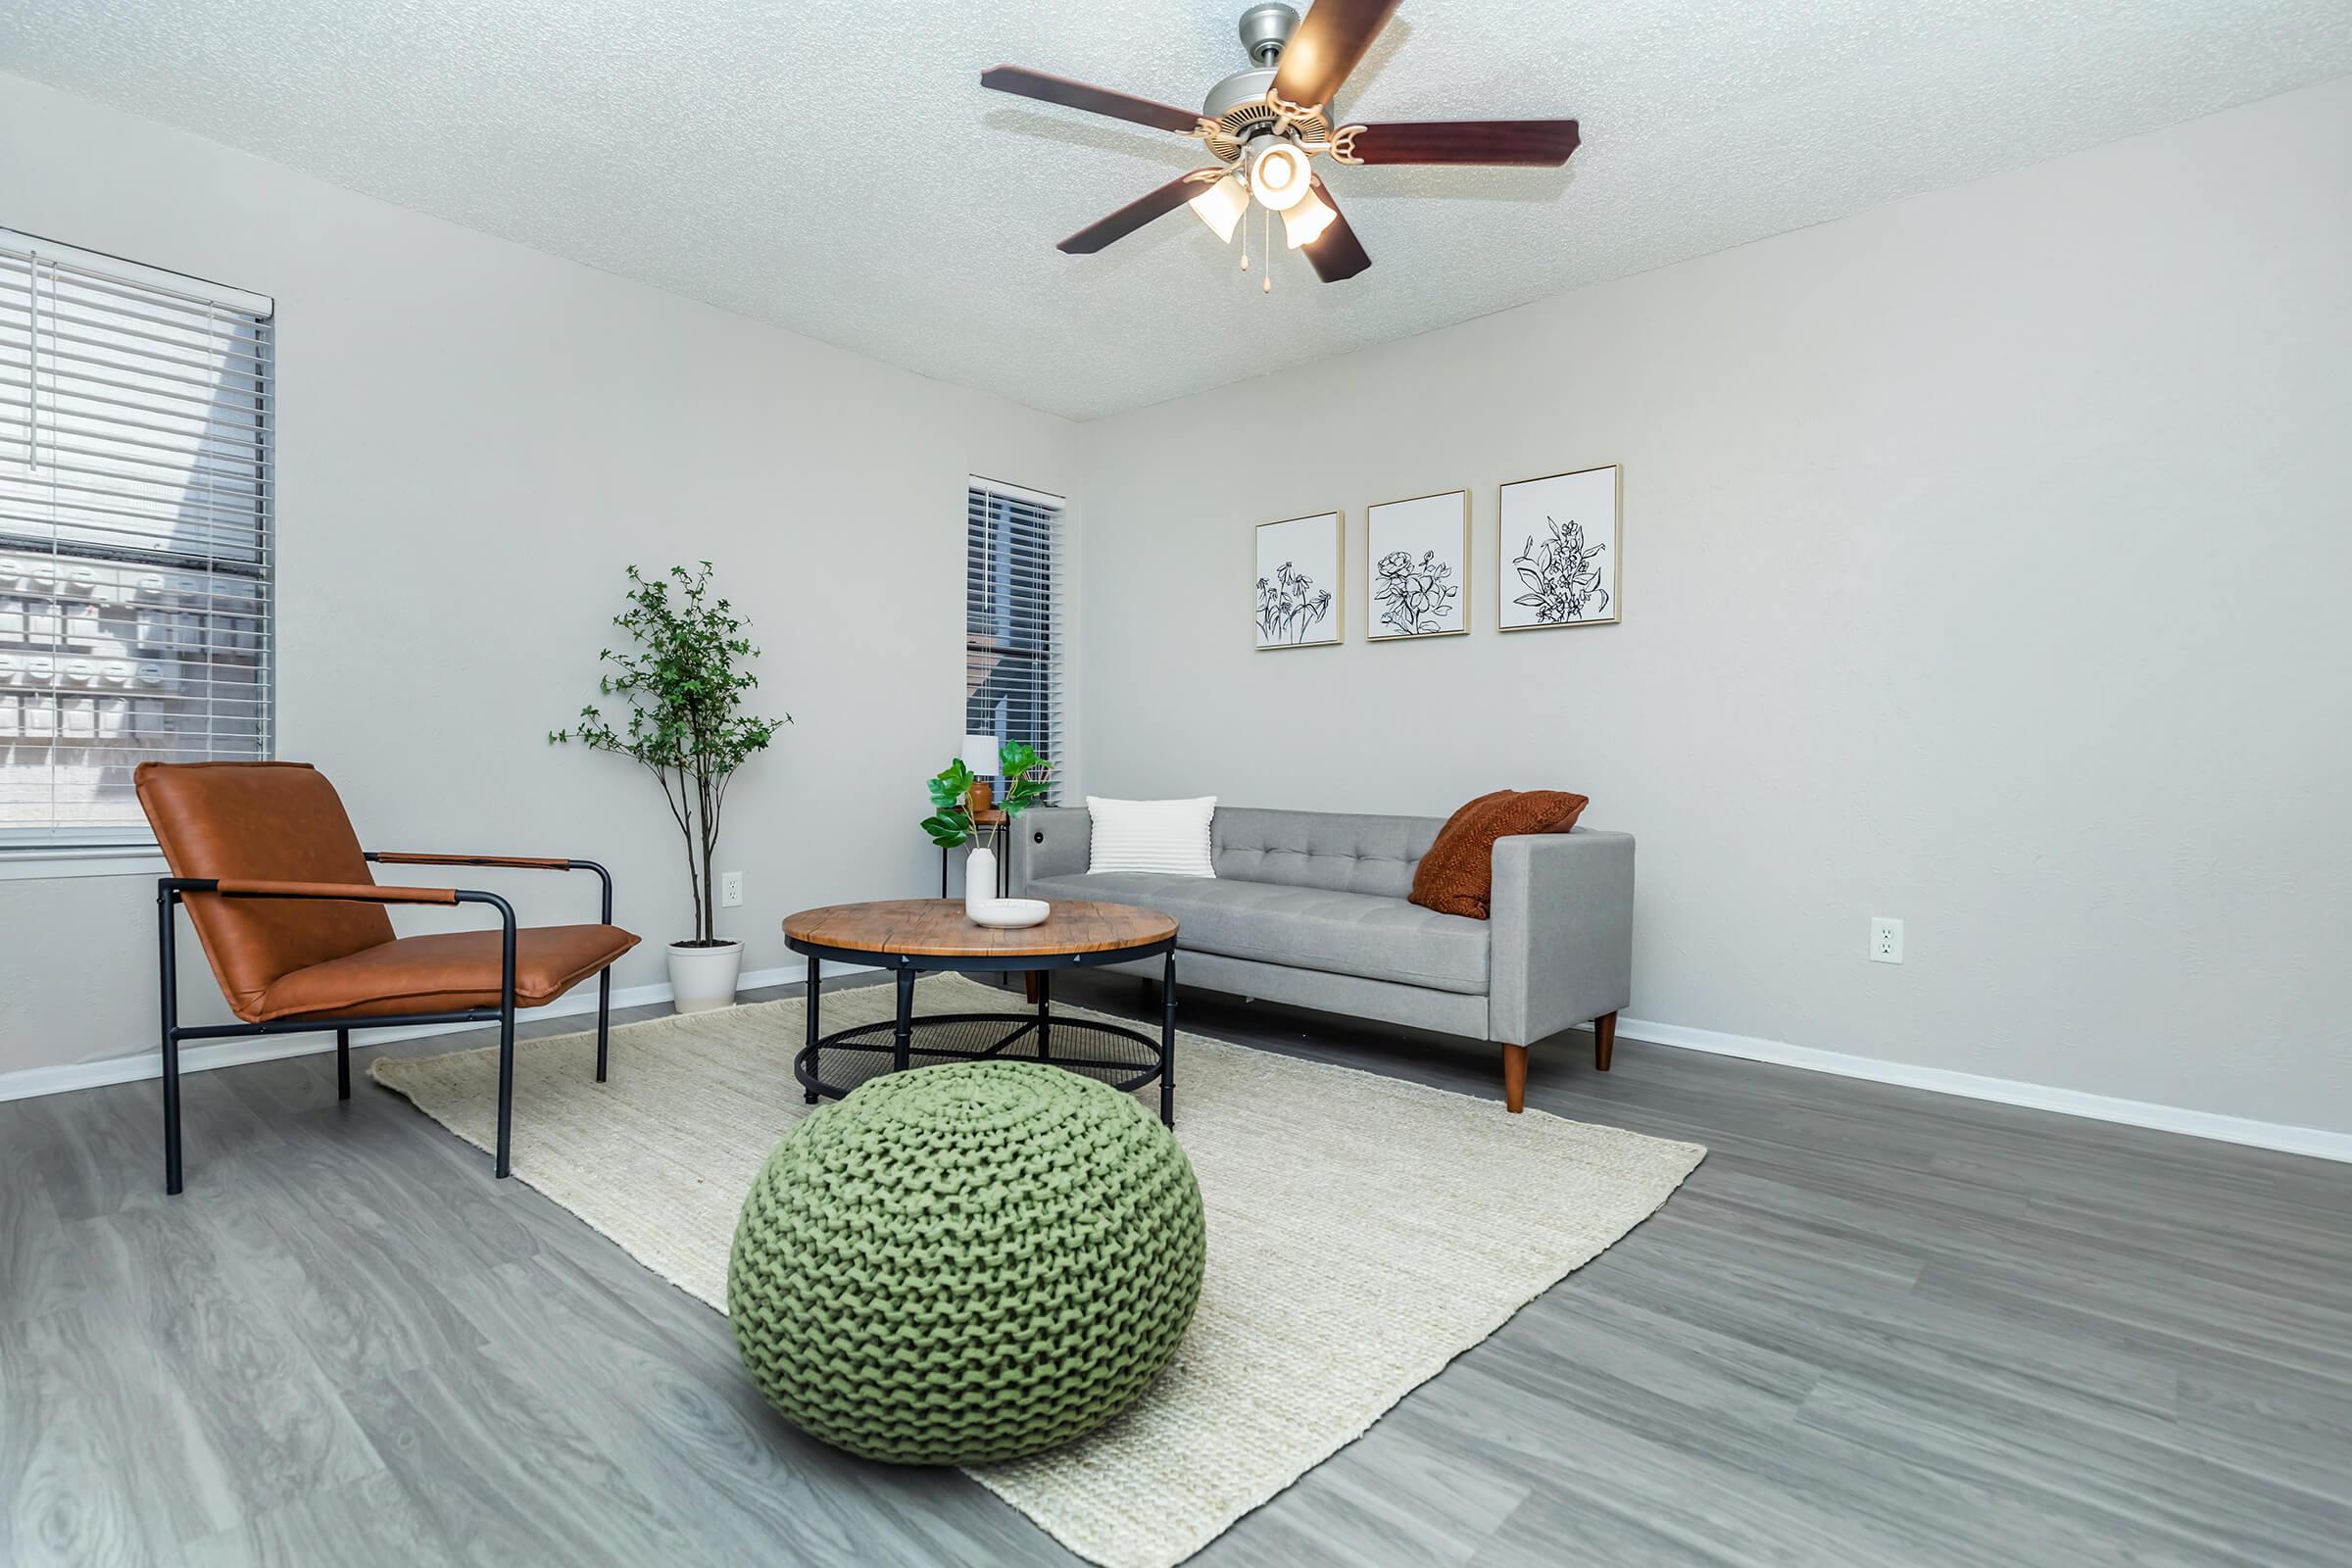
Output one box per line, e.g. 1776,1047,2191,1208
1023,872,1487,995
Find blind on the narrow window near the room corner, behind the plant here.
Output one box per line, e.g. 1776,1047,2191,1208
964,479,1065,800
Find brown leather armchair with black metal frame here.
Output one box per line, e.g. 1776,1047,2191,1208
131,761,637,1192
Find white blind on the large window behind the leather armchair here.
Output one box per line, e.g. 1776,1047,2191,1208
0,230,275,851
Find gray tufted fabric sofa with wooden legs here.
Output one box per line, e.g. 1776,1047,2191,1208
1009,807,1633,1109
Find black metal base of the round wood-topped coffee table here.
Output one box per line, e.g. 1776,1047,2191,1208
793,948,1176,1126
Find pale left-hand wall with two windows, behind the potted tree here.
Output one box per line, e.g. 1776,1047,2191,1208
0,75,1075,1072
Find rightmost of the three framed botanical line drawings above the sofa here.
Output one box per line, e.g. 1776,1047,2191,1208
1495,464,1623,632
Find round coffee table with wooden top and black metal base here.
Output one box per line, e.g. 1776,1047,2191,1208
783,898,1176,1126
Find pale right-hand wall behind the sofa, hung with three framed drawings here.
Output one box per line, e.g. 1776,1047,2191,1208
1084,80,2352,1131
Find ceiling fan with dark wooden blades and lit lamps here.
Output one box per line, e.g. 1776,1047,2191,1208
981,0,1576,287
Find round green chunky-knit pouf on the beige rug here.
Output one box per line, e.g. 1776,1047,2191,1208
727,1062,1206,1464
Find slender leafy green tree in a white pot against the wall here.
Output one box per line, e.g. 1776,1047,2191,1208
548,562,793,1013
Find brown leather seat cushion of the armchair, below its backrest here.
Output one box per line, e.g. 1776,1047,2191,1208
249,926,637,1022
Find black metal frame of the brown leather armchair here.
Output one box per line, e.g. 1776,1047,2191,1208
155,851,612,1195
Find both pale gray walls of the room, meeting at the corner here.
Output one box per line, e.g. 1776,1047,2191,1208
0,64,2352,1131
